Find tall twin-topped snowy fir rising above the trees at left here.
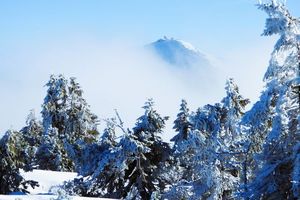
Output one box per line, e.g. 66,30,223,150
37,75,99,171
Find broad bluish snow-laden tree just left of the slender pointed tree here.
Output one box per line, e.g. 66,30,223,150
163,104,223,199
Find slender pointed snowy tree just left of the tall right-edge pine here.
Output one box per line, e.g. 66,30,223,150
218,78,250,198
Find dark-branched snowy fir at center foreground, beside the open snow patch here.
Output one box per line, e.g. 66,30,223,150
66,100,171,199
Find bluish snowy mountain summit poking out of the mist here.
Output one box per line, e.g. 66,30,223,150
149,36,209,67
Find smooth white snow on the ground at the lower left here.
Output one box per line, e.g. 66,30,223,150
0,170,115,200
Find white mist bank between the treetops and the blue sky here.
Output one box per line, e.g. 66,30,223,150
0,38,272,141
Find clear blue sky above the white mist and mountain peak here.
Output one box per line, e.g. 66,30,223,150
0,0,300,52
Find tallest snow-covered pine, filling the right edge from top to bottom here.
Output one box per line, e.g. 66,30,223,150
247,0,300,199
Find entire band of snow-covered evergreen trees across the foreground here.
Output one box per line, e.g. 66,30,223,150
0,0,300,200
